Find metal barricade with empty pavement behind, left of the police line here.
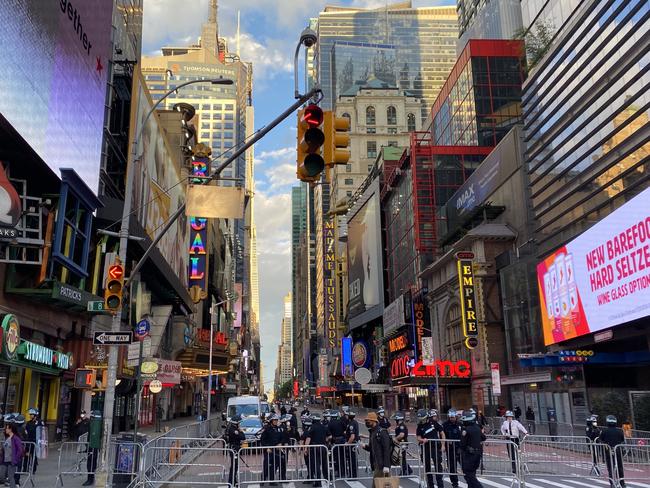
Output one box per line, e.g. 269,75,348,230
141,445,237,488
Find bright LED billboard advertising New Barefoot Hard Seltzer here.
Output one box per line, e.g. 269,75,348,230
537,188,650,345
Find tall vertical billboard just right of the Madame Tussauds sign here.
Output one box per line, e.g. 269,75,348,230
348,180,384,328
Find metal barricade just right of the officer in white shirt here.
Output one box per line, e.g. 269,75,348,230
520,435,614,483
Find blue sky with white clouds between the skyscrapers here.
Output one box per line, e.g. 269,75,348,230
142,0,455,390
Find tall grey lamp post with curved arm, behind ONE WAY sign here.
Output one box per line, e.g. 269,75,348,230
97,78,233,478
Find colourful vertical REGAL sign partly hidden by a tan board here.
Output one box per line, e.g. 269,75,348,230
188,156,210,303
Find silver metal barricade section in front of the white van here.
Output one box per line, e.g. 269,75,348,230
237,445,330,487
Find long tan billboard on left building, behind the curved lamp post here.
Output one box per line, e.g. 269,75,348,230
129,72,191,287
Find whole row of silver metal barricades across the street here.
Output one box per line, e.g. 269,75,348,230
55,435,650,487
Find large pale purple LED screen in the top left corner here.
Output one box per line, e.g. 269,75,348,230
0,0,113,192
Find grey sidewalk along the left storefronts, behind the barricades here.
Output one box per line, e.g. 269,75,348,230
33,417,197,488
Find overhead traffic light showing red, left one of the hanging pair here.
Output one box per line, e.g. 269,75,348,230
296,104,325,182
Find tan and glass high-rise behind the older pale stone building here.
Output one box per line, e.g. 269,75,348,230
315,1,458,115
